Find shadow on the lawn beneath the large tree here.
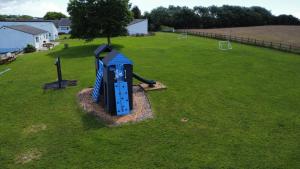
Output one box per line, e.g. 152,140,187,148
48,44,124,59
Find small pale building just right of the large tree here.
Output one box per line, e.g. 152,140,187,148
127,19,148,35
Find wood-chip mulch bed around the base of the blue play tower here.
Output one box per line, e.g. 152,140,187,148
78,86,153,126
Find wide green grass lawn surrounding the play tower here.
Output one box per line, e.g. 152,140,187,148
0,33,300,169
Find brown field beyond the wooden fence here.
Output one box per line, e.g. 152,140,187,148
184,26,300,45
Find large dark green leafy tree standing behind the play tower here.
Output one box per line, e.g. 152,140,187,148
68,0,132,45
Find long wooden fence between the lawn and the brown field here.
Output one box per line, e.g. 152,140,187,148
176,30,300,54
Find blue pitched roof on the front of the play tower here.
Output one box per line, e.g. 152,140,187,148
102,50,133,66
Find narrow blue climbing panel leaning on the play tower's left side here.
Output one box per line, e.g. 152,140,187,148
92,60,103,103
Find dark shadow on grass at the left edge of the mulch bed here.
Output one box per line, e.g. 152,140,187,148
82,113,106,130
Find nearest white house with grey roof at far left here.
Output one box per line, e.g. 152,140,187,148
0,25,49,49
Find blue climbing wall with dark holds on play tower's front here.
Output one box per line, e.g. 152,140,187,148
115,82,130,116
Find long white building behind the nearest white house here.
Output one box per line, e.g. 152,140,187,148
0,20,58,40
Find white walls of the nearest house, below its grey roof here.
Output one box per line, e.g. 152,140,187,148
0,27,49,49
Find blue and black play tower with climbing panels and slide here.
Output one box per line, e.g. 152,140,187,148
92,45,156,116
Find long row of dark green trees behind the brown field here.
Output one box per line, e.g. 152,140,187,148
143,5,300,31
